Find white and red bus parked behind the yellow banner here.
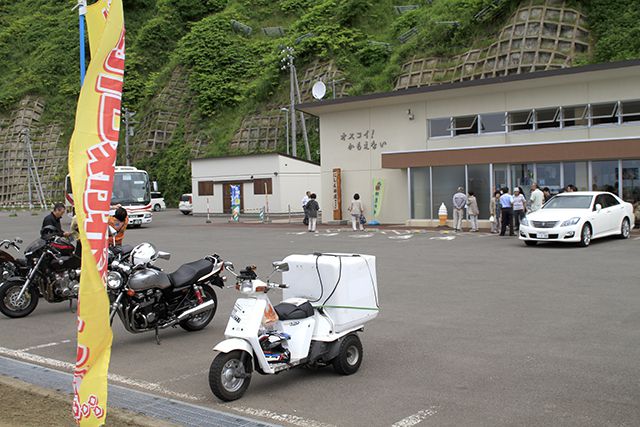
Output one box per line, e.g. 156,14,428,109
64,166,153,226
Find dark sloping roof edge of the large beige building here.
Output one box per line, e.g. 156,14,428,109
296,59,640,115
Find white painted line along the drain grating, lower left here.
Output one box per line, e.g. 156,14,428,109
0,347,335,427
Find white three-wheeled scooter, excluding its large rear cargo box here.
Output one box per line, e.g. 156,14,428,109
209,262,377,401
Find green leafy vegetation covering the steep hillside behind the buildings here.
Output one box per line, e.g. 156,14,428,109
0,0,640,204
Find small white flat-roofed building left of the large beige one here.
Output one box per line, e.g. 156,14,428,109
191,153,322,214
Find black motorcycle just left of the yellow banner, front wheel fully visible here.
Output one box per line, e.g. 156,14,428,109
0,230,80,318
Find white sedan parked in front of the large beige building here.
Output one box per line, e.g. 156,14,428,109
520,191,633,246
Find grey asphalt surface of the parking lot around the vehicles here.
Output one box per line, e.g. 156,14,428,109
0,211,640,427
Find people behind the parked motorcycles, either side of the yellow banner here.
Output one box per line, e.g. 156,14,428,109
40,203,129,247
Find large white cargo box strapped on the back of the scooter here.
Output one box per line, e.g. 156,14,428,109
282,253,380,333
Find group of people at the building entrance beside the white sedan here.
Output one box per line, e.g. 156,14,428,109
453,182,578,236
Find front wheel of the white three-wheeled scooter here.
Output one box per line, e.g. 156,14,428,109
209,350,251,402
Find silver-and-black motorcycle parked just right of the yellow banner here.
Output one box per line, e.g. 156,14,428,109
107,244,224,344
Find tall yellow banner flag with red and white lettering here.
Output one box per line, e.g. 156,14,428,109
69,0,125,426
